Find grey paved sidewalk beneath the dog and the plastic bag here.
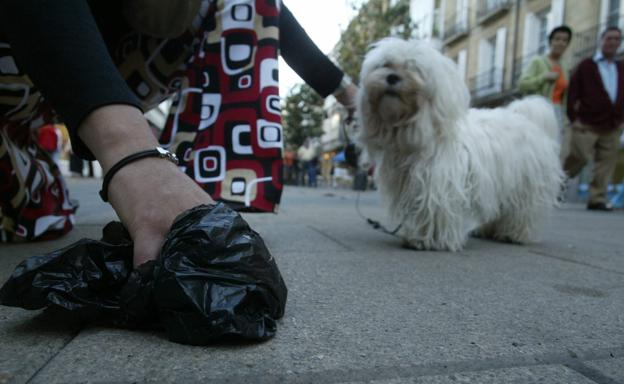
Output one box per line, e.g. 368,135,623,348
0,179,624,384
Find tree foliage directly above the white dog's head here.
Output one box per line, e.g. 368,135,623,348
336,0,413,82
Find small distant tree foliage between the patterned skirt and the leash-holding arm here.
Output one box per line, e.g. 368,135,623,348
282,84,323,148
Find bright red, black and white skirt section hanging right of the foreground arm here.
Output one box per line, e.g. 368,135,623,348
160,0,283,212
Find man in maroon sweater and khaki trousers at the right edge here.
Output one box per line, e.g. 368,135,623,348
564,27,624,211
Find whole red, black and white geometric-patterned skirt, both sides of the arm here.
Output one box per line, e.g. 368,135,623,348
0,0,283,241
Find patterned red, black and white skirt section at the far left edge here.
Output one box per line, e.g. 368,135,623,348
0,41,77,242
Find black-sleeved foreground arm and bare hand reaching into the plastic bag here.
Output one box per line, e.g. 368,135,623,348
0,0,212,265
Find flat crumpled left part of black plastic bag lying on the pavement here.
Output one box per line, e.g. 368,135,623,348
0,224,132,320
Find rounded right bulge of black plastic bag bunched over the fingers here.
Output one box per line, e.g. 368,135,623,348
154,204,287,344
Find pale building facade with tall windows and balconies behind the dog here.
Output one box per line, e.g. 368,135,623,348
411,0,624,106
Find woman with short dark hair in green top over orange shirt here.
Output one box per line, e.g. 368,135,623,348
518,25,572,147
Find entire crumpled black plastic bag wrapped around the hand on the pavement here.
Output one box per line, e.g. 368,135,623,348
0,203,287,345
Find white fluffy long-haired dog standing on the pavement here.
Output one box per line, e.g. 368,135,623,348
358,38,563,251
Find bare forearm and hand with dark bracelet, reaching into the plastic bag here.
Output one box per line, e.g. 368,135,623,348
78,105,214,267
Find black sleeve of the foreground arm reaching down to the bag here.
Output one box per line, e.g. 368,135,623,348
0,0,140,159
